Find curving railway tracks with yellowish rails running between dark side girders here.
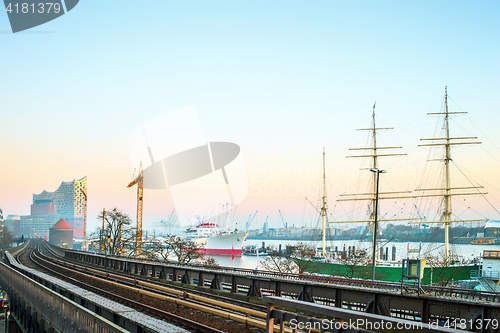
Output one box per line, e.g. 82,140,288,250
17,240,290,332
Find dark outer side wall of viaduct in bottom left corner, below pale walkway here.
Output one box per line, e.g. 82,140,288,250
0,256,128,333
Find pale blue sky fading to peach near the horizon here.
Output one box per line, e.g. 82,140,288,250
0,0,500,230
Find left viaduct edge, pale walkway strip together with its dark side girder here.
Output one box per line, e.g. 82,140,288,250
0,252,187,333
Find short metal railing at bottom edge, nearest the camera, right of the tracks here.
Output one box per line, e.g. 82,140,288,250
263,296,464,333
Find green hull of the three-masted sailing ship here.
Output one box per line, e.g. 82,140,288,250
296,259,479,285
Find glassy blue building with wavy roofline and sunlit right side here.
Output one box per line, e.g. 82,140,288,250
20,176,87,237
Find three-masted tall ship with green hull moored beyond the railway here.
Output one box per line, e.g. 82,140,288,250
298,88,488,285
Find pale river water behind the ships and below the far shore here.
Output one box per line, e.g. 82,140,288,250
205,239,500,269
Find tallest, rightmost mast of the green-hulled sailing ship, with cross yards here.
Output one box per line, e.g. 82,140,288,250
409,86,488,265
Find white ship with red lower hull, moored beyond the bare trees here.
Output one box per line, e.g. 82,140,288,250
184,222,248,256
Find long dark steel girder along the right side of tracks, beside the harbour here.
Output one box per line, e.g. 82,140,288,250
61,240,500,331
